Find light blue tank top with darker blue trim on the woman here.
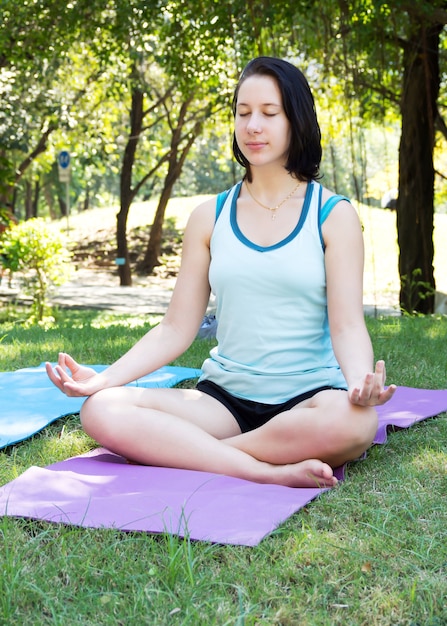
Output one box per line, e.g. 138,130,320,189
201,182,347,404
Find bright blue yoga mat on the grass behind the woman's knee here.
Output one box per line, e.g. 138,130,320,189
0,363,201,448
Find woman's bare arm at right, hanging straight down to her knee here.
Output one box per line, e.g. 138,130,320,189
323,196,395,406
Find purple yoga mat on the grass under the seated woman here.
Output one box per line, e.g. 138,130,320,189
0,387,447,546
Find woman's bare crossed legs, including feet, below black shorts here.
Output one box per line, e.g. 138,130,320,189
81,387,377,487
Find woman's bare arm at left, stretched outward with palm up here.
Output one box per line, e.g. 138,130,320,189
47,199,215,396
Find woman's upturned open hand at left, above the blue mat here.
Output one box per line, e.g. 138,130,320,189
45,352,104,396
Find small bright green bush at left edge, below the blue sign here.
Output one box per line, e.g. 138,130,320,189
0,219,69,321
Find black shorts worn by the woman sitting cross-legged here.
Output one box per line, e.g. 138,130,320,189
196,380,344,433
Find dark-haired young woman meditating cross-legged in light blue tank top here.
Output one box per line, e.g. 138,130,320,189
47,57,395,487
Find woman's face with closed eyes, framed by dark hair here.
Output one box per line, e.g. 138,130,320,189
235,75,290,167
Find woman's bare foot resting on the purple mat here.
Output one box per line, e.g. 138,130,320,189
271,459,338,489
